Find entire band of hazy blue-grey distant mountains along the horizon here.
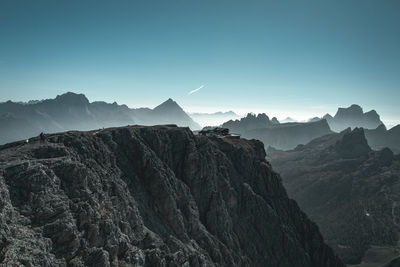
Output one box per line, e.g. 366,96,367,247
0,92,400,157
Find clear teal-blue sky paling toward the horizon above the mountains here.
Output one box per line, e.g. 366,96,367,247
0,0,400,125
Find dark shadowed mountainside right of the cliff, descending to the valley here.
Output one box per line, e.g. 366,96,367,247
267,128,400,266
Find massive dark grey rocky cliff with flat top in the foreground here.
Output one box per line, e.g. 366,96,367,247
0,126,343,266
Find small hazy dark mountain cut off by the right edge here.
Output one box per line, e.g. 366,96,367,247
365,124,400,154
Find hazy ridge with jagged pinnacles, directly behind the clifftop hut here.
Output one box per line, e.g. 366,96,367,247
222,113,332,150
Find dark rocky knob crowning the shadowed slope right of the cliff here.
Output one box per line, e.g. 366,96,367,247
335,128,371,158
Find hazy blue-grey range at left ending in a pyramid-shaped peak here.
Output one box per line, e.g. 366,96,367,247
0,92,201,143
